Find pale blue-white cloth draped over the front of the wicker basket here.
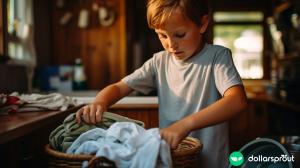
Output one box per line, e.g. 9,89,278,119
67,122,172,168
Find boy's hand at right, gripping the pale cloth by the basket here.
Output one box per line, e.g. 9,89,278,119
160,120,190,149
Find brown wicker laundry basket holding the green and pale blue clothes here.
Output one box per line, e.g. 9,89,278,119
45,137,202,168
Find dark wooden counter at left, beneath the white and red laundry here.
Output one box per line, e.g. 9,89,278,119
0,107,78,167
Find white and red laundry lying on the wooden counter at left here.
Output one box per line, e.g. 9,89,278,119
0,92,80,114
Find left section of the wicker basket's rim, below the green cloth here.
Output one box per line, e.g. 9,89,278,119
45,144,94,161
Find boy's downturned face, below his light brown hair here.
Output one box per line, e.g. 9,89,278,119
155,9,208,61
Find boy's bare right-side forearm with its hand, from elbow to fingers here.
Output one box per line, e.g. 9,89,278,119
161,86,247,148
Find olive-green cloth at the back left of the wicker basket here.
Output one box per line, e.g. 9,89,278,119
49,112,145,152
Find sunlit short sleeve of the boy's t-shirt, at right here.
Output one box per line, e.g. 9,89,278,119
214,48,243,96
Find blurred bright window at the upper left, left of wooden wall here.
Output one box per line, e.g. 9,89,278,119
6,0,35,66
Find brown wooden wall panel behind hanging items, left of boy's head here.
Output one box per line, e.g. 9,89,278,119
51,0,126,90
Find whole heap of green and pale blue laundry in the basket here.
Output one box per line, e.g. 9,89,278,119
49,112,172,168
